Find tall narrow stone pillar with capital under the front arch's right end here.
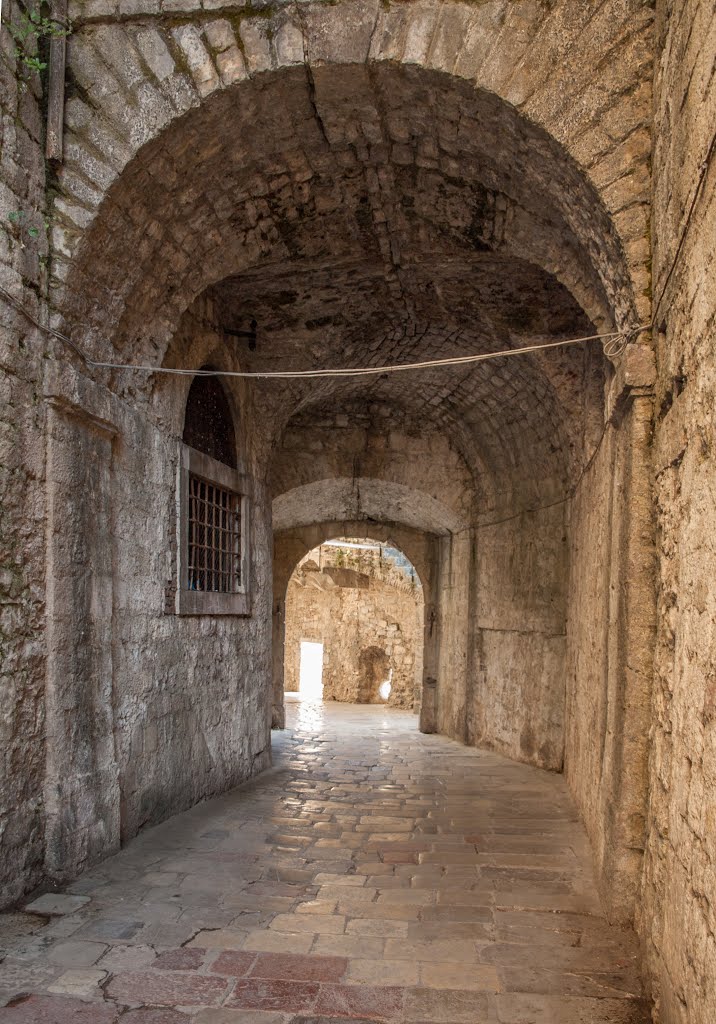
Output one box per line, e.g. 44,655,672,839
599,345,656,923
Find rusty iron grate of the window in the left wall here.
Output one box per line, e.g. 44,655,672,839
187,473,242,594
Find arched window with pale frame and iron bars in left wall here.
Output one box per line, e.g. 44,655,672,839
175,368,251,615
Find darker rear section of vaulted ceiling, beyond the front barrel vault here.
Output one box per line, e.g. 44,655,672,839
213,252,593,505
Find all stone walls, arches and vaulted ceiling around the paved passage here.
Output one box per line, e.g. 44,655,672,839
0,0,716,1024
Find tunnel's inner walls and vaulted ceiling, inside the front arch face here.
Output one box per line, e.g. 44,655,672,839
12,37,650,1015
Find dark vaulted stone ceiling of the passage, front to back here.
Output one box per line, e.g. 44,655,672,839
62,65,628,507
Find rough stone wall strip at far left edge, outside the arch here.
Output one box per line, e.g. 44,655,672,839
0,0,55,906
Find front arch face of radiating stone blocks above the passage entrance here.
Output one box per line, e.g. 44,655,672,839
52,0,651,350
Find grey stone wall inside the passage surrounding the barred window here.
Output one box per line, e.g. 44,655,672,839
37,308,270,879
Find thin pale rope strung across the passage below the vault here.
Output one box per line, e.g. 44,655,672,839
0,287,651,380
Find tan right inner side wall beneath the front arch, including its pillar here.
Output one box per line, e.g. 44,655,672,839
565,385,655,922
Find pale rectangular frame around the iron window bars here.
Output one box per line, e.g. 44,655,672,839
175,443,251,615
